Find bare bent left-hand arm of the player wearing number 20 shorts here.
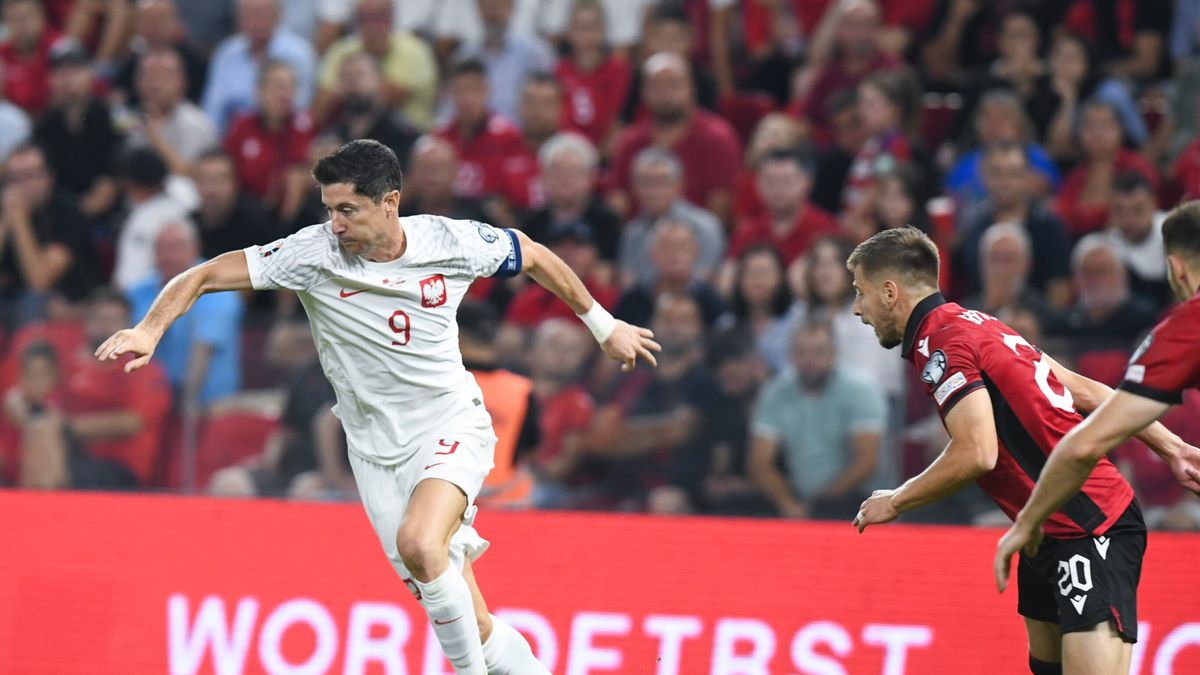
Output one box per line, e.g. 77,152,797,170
854,388,1000,532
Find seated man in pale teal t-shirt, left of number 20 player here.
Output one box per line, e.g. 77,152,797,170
750,323,887,520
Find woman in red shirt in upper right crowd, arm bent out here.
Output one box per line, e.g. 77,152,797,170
1055,100,1158,239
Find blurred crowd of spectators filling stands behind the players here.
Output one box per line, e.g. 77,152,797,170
0,0,1200,530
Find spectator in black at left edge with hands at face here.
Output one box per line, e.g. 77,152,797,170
0,144,100,329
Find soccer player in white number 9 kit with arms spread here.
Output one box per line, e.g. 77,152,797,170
96,141,660,675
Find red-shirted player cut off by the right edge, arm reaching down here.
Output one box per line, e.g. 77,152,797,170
995,202,1200,634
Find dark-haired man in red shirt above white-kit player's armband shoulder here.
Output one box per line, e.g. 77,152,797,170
434,59,523,199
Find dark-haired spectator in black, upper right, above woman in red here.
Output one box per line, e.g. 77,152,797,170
1030,31,1148,163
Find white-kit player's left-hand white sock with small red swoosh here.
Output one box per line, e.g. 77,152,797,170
413,565,487,675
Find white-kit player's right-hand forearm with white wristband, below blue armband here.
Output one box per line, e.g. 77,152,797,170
516,231,662,371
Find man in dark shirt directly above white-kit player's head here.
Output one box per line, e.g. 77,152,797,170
326,50,420,169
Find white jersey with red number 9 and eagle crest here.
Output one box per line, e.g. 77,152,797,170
245,215,521,464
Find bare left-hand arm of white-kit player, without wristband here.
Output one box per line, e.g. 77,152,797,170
96,251,251,372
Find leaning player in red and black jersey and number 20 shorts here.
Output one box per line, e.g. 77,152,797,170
846,227,1200,675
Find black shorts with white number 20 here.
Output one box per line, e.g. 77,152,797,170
1016,500,1146,643
